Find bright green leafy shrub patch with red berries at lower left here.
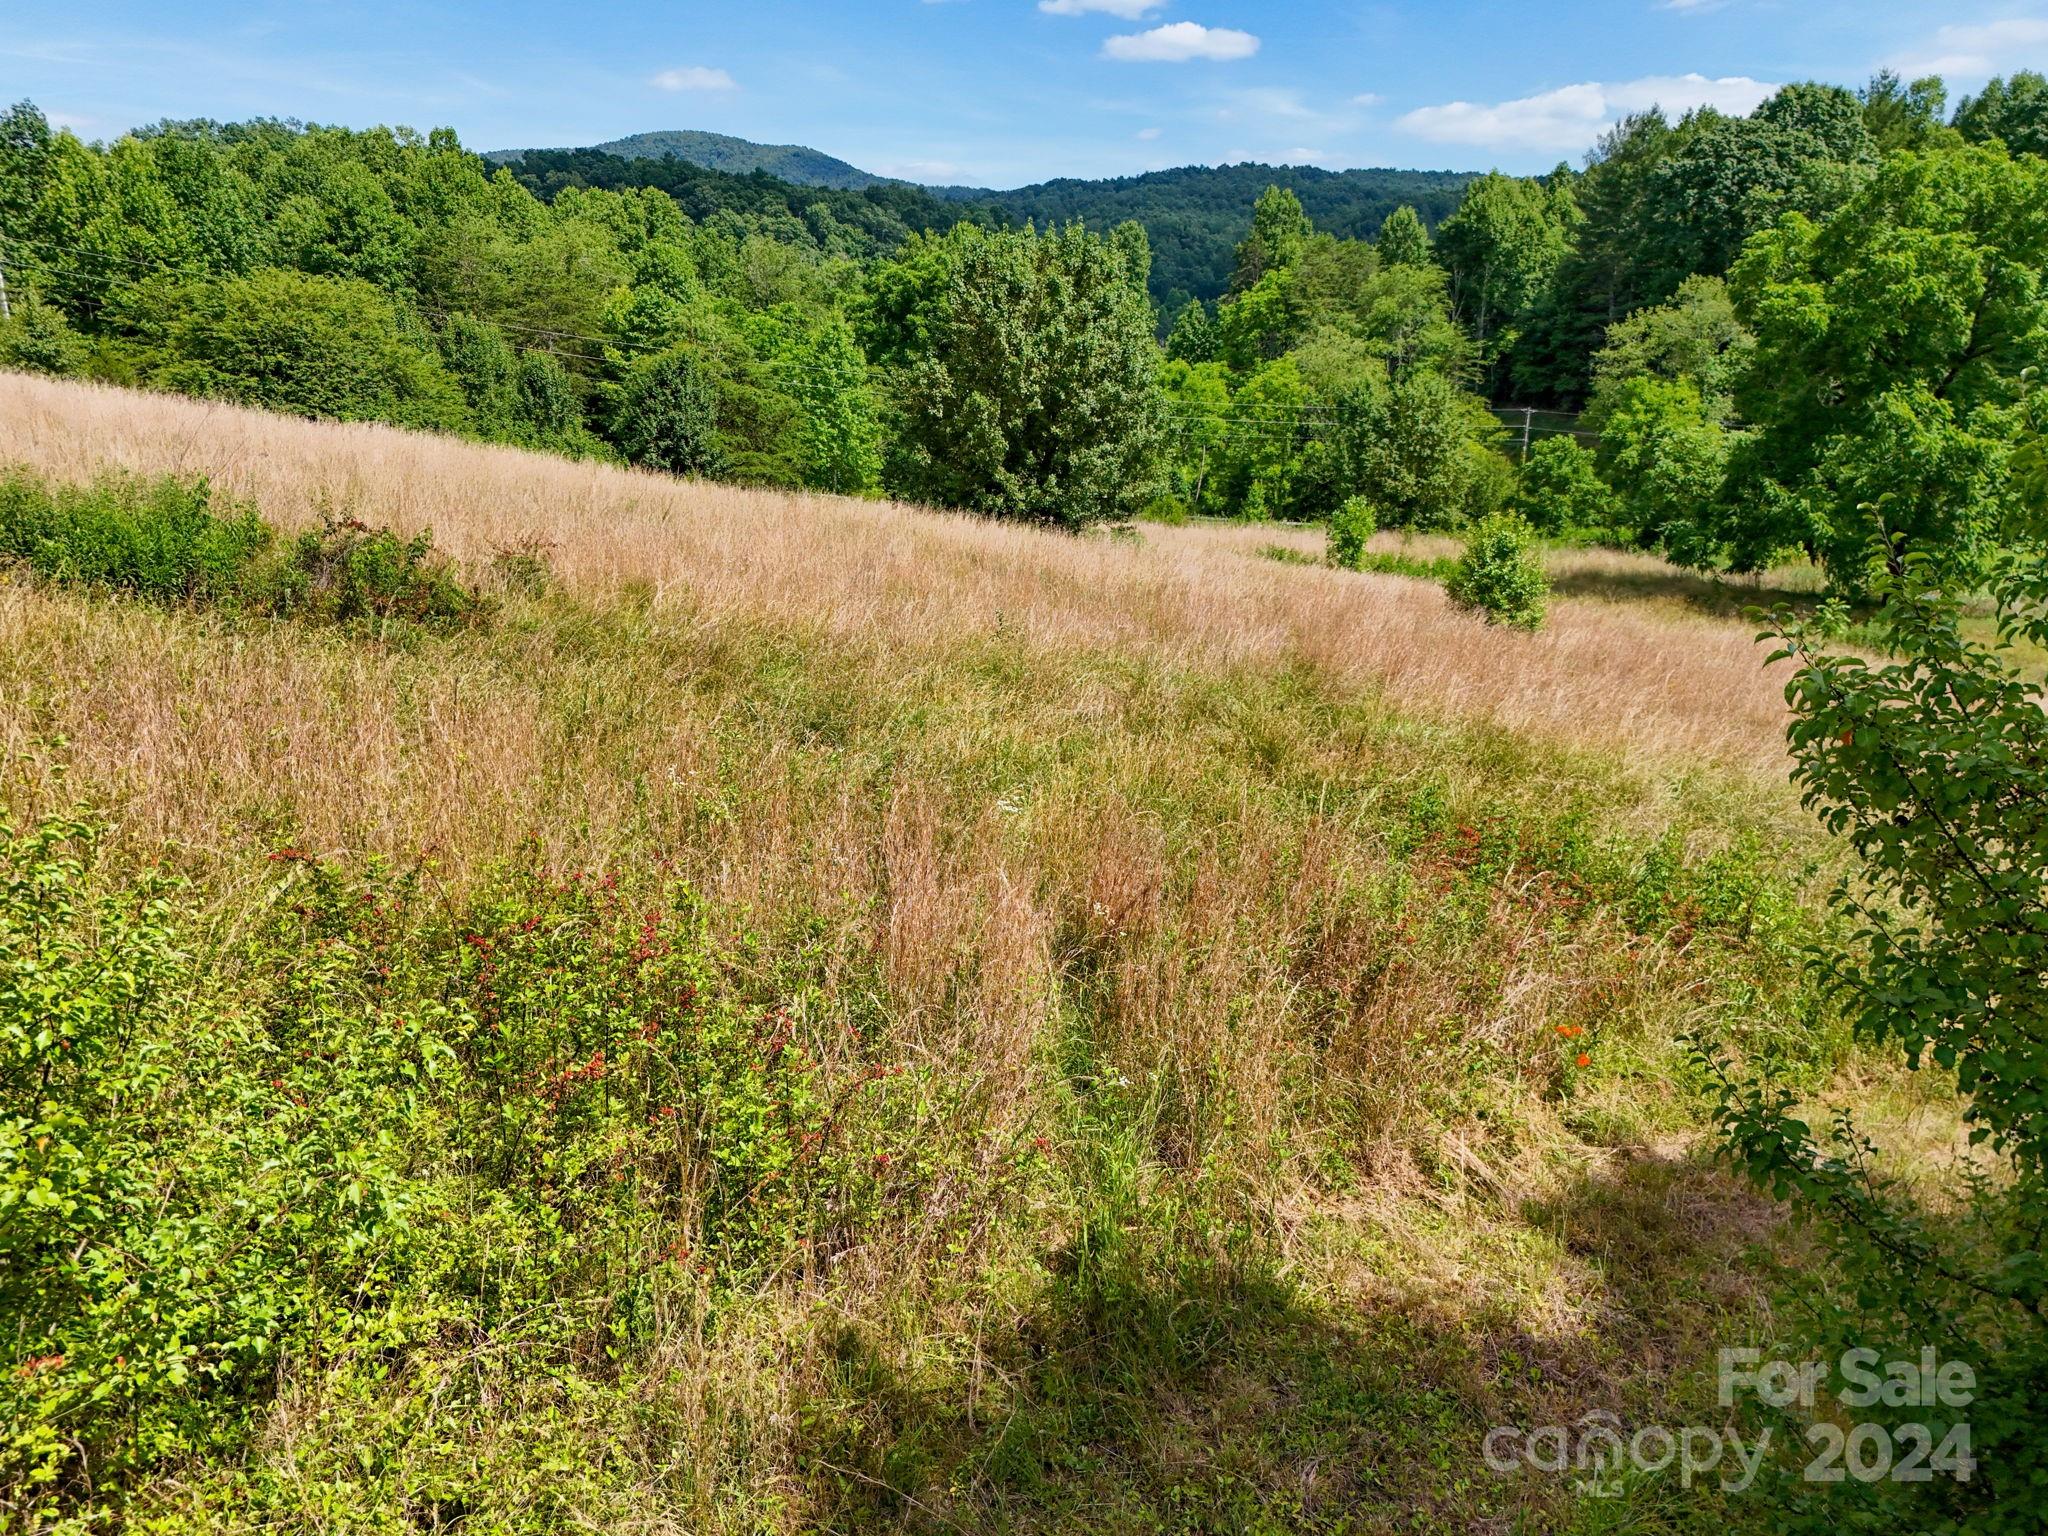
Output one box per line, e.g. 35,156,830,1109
0,815,907,1530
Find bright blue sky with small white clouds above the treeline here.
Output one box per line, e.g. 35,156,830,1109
0,0,2048,186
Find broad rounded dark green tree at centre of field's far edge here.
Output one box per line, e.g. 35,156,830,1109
901,225,1163,528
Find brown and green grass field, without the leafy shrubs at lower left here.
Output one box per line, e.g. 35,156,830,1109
0,375,1859,1536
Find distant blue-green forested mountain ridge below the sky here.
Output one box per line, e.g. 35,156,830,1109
485,129,1473,309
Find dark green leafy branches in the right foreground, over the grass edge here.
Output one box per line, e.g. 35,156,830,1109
1710,549,2048,1532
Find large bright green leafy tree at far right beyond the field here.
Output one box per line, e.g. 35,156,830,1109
1720,147,2048,586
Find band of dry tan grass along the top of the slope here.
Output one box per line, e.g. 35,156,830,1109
0,375,1784,772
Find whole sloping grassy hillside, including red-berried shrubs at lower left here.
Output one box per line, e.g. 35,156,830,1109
0,375,1916,1532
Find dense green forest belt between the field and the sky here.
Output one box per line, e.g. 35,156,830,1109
0,74,2048,590
